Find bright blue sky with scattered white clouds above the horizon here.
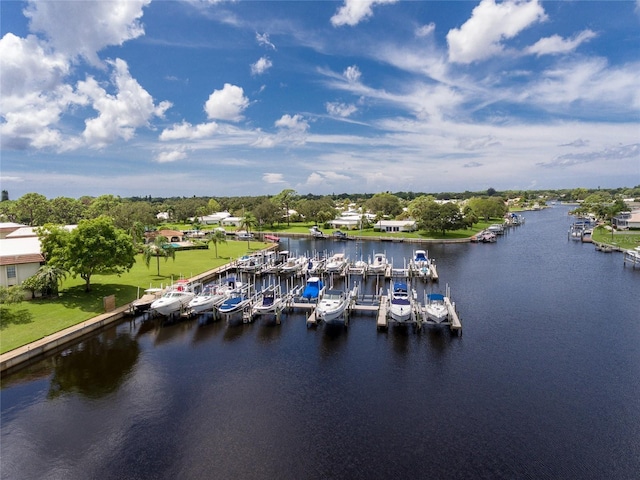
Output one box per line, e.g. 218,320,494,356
0,0,640,199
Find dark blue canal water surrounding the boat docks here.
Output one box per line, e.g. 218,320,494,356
0,206,640,480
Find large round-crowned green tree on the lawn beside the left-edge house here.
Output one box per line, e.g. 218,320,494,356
38,216,135,292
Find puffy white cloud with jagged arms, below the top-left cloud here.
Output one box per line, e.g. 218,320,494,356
78,59,171,148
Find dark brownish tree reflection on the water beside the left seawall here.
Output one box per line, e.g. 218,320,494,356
47,329,140,399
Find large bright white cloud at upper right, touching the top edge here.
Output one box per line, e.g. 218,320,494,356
447,0,547,63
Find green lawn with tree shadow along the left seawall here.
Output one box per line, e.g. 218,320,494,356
0,241,267,353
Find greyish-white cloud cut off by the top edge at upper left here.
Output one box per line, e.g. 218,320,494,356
25,0,151,64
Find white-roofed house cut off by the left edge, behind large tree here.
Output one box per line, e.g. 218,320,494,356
0,236,44,287
